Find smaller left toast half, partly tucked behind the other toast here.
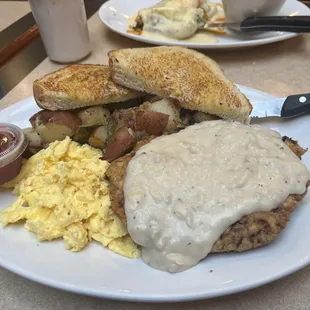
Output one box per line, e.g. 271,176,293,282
33,64,141,111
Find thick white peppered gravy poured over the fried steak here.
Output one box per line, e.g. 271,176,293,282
124,121,310,272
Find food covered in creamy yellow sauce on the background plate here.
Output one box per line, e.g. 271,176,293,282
129,0,225,42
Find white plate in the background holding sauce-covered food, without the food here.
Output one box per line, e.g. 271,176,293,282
99,0,310,49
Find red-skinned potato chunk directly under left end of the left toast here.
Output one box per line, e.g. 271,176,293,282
30,110,81,143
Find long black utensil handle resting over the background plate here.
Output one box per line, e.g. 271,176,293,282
240,16,310,33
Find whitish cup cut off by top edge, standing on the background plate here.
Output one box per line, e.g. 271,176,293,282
222,0,286,22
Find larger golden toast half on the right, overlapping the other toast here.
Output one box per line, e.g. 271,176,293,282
108,46,252,122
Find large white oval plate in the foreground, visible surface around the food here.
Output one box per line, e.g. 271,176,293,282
0,87,310,301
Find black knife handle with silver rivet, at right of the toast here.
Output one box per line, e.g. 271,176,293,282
281,94,310,118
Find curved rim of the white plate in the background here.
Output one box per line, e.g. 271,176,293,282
98,0,310,50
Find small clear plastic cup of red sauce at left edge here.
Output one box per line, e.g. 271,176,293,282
0,123,28,185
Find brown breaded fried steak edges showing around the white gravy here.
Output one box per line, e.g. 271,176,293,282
106,136,310,253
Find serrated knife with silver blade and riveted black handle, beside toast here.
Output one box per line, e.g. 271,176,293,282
250,93,310,118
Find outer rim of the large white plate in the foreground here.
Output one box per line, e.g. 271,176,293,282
0,85,310,303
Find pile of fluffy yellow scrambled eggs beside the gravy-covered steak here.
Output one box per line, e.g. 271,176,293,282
0,138,140,258
